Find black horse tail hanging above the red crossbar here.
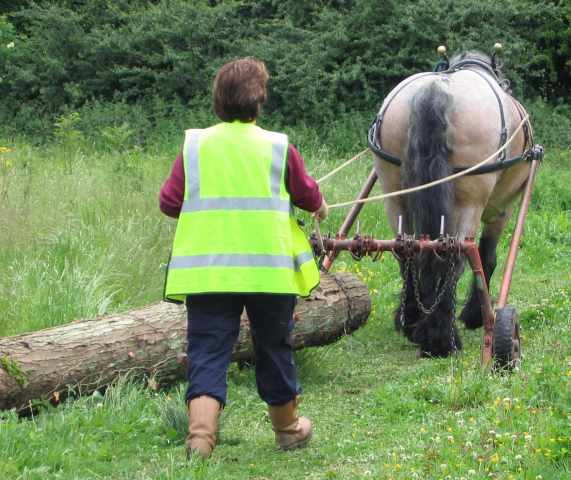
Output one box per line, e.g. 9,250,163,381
401,80,454,238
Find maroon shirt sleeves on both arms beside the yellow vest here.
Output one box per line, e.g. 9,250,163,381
159,144,323,218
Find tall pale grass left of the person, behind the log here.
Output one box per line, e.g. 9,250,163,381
0,139,172,335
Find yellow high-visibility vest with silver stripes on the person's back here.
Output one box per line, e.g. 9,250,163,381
164,122,319,301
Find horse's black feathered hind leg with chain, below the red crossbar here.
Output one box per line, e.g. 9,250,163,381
413,257,462,357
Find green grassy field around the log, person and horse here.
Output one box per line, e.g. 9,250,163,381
0,109,571,480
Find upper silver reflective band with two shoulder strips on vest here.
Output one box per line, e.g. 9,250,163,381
182,130,291,212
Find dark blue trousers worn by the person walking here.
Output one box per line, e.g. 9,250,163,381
186,294,301,405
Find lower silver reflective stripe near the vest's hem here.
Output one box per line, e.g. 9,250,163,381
169,252,313,270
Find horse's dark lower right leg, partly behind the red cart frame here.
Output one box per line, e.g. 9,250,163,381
460,209,511,330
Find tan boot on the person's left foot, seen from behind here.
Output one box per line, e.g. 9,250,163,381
186,395,220,458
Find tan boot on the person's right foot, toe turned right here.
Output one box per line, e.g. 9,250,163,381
268,397,313,450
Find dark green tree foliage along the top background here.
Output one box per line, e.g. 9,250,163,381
0,0,571,129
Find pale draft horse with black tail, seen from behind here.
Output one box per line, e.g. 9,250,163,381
369,51,533,357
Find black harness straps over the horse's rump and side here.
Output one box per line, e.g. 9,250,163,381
368,59,533,175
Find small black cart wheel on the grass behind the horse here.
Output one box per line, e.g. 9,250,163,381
493,305,521,370
